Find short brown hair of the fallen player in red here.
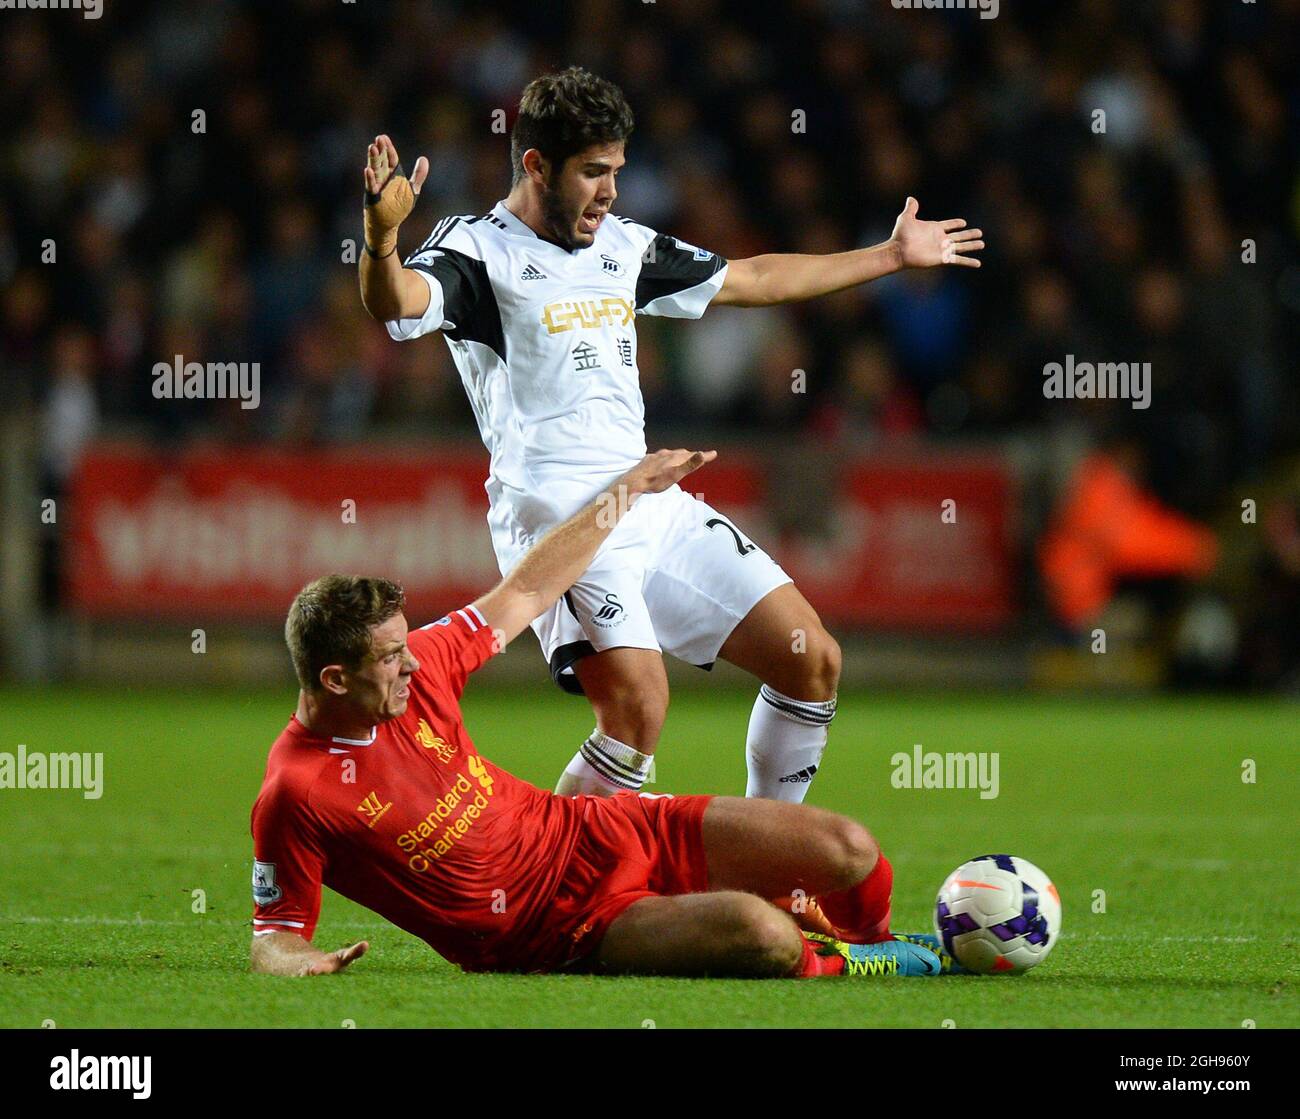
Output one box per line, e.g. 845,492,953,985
285,574,406,691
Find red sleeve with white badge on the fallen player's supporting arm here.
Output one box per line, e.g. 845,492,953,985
252,785,325,940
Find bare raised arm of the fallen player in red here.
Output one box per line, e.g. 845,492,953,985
475,450,718,646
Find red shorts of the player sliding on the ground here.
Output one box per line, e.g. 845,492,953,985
542,793,712,970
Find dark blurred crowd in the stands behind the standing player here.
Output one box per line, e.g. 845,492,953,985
0,0,1300,686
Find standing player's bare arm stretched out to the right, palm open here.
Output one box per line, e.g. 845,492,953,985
712,198,984,307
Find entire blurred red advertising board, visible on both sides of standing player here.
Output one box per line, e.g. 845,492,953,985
66,446,1014,629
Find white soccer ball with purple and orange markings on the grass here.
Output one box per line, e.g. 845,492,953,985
935,855,1061,975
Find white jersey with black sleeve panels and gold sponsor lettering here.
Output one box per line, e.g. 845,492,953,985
387,200,727,528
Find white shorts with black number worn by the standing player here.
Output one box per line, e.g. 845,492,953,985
490,486,792,695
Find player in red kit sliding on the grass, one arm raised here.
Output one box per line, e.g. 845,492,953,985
252,451,949,977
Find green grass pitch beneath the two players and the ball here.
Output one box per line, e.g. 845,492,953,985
0,685,1300,1028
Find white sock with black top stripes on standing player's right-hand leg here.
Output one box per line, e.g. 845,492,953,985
745,684,835,804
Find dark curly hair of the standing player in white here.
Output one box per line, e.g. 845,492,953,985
510,66,633,186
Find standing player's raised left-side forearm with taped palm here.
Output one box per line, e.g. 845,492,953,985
358,135,429,322
